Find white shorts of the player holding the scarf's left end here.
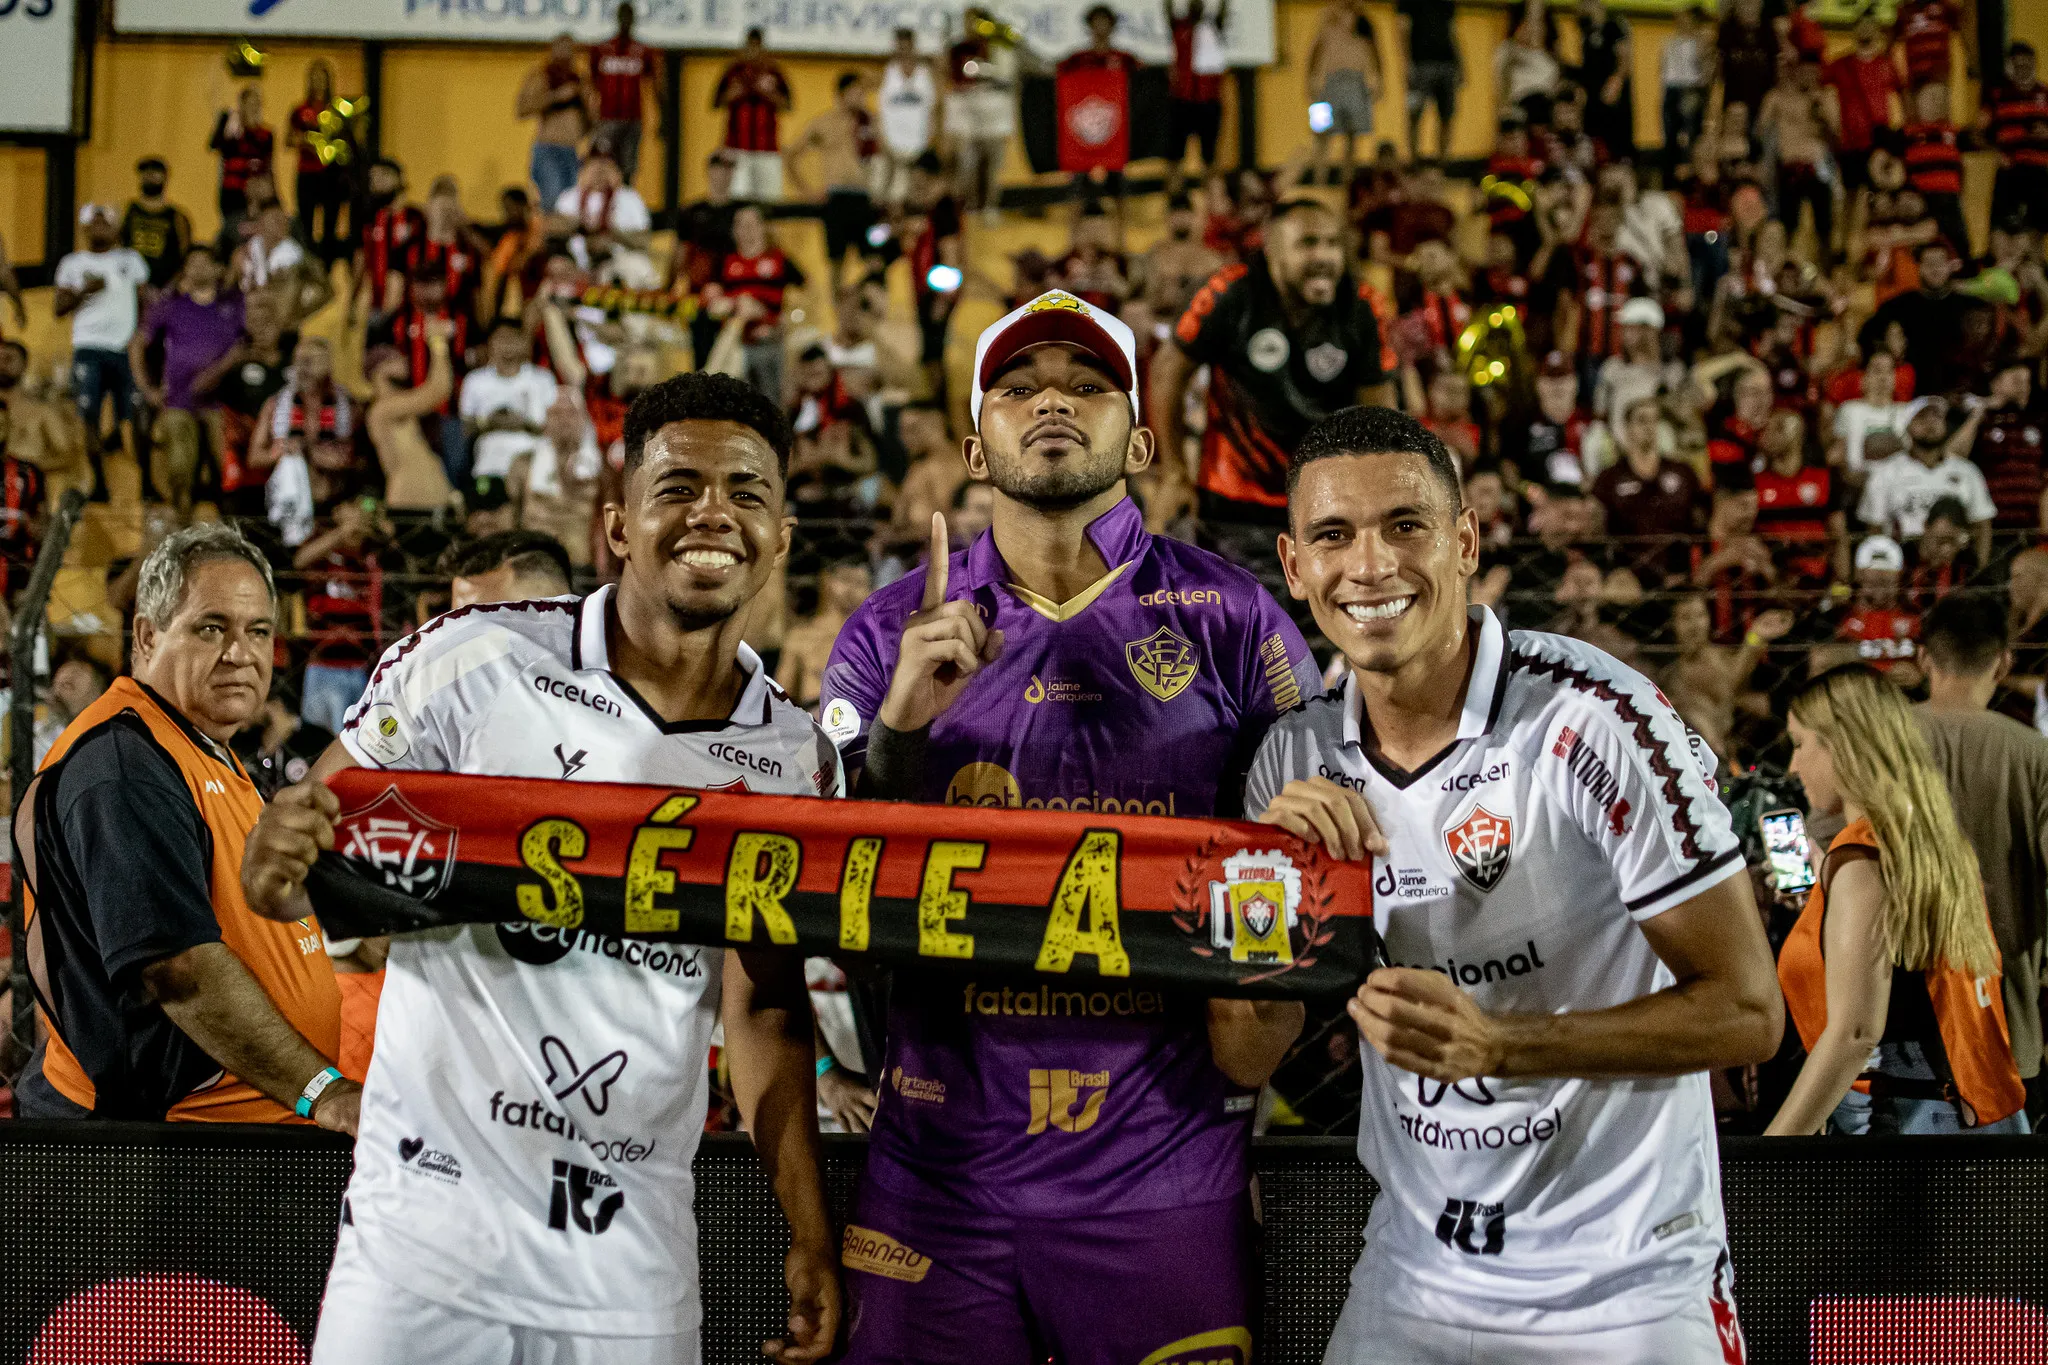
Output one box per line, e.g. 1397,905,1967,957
311,1224,702,1365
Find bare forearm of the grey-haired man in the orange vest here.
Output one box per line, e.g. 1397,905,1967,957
141,943,332,1109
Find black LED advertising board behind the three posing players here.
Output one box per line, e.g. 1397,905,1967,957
0,1124,2048,1365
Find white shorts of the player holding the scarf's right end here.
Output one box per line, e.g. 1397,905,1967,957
1323,1275,1749,1365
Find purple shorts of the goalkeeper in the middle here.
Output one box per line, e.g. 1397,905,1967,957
840,1181,1251,1365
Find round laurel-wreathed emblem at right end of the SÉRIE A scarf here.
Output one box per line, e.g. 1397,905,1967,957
1174,843,1333,980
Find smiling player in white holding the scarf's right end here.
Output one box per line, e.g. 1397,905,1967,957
1245,407,1784,1365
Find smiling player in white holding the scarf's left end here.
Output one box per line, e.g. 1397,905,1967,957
242,375,844,1365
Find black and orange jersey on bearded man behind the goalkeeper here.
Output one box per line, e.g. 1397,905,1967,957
1174,256,1399,508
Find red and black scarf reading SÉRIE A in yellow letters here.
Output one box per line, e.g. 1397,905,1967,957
307,767,1380,994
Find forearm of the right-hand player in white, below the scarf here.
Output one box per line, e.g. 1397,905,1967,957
1495,976,1784,1078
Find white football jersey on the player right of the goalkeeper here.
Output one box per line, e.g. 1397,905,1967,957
1245,608,1743,1332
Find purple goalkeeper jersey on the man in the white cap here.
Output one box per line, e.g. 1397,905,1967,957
821,499,1321,1218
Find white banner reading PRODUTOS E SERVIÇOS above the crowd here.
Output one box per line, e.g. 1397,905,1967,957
116,0,1274,65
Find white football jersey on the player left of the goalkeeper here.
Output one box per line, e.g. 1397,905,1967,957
342,587,844,1336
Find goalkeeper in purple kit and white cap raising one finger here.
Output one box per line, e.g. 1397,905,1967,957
823,291,1319,1365
